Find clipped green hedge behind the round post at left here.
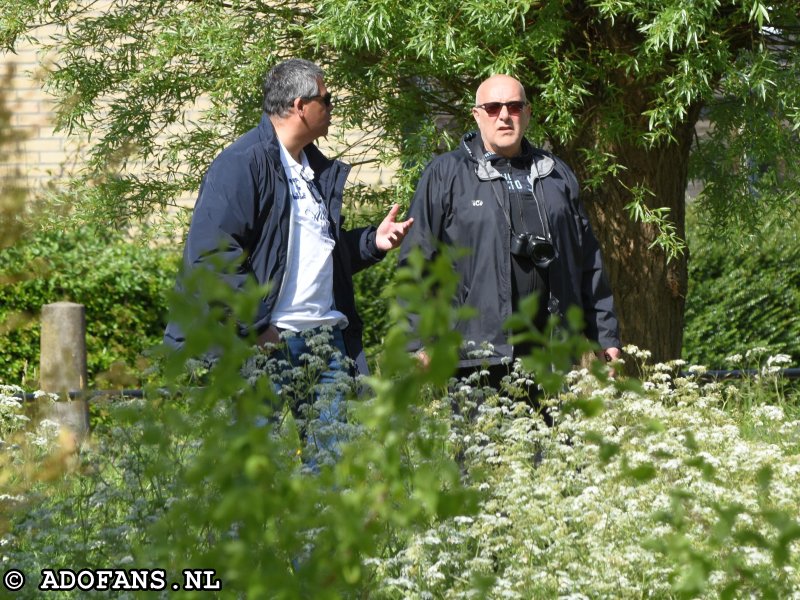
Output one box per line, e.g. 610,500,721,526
0,228,177,388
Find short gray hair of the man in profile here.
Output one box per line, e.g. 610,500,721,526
262,58,324,117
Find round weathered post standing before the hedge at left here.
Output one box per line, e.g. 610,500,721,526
39,302,89,440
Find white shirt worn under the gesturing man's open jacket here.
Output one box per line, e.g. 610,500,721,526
272,142,347,331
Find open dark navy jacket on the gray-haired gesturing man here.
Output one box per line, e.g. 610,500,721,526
164,115,385,372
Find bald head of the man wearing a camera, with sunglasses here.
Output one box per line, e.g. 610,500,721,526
472,75,531,158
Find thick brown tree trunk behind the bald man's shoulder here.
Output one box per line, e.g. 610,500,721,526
556,113,699,362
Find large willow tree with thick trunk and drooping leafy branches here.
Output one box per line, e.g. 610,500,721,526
0,0,800,360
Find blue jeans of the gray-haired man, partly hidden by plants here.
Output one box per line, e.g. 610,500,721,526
273,329,353,470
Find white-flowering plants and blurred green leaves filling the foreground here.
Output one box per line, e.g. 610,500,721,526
6,338,800,599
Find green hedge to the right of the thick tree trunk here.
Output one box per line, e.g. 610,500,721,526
684,209,800,369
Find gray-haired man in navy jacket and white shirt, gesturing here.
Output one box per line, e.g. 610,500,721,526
164,59,412,436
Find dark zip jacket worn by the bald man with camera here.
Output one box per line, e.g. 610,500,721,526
399,132,620,367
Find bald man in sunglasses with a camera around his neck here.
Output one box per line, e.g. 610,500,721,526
399,75,620,393
